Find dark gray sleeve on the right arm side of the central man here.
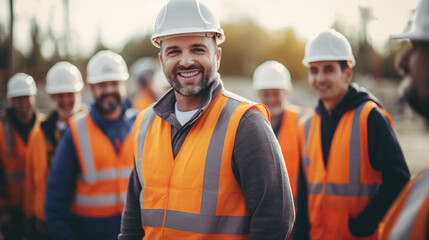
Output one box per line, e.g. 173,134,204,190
232,109,295,240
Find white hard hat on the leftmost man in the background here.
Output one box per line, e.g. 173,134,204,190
7,73,37,98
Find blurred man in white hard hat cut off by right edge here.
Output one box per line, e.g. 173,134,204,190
379,0,429,240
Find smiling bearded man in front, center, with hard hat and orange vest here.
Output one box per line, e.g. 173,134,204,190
119,0,295,240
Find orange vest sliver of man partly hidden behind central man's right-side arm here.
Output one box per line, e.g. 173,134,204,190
278,105,301,199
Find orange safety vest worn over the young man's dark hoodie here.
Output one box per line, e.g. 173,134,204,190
299,101,393,239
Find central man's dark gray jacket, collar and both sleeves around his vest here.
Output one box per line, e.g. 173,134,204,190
119,79,295,240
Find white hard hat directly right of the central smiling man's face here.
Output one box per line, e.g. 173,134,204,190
253,61,292,90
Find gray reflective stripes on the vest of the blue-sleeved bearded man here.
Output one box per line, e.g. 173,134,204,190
75,114,132,206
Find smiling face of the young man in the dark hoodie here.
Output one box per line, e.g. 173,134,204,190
308,61,353,110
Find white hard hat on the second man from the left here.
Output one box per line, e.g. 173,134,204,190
46,62,83,94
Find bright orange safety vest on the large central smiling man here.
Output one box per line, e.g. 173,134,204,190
134,91,268,240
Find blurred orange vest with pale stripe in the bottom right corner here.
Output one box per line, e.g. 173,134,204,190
379,170,429,240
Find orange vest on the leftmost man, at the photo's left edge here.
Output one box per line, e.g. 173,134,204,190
0,117,40,209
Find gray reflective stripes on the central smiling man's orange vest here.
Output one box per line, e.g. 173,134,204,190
136,98,250,234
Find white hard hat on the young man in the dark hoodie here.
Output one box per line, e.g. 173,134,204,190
302,29,356,67
